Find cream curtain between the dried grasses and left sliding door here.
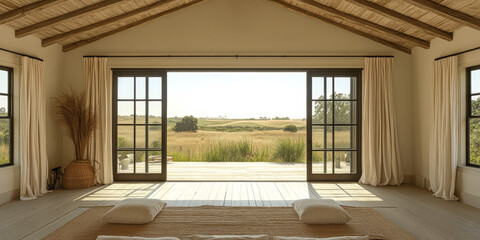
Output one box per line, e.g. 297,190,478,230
84,57,113,184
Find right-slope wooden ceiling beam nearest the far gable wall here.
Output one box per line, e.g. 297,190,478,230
270,0,411,54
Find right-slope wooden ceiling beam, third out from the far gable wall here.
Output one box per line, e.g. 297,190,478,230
347,0,453,41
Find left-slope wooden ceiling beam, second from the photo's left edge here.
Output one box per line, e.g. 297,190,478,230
15,0,124,38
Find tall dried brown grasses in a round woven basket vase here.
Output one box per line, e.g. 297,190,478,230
55,88,97,189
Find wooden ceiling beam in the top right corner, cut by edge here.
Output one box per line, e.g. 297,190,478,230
406,0,480,30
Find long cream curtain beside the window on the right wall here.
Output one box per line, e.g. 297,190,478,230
429,56,461,200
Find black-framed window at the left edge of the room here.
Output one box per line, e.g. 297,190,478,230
0,66,13,167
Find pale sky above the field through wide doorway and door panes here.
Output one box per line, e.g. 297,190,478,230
118,72,362,119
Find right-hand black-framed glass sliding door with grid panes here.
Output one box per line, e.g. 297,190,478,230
307,70,361,181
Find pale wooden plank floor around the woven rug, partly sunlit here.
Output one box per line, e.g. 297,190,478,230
0,182,480,240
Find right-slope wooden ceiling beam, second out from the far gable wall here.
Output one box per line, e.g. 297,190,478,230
297,0,430,49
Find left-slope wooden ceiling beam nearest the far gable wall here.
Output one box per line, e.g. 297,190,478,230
63,0,204,52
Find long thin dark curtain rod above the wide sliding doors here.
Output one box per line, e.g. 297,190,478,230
83,55,394,58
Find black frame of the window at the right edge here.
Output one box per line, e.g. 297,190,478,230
465,65,480,168
